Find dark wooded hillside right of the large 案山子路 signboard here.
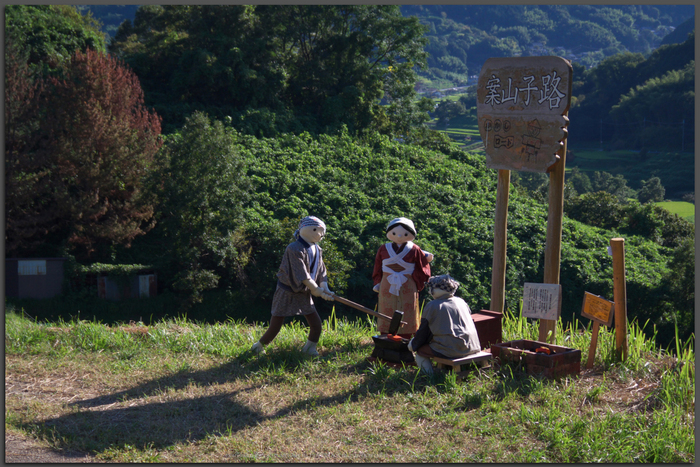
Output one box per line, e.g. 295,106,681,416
569,32,695,151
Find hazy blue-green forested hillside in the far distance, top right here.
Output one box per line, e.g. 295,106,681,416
401,5,695,86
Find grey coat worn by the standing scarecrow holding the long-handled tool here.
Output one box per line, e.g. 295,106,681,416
272,240,328,316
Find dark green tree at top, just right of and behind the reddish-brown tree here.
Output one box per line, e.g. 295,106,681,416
109,5,283,133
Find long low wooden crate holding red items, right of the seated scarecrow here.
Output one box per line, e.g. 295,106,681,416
491,339,581,378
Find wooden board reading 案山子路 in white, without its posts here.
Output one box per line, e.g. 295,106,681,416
476,57,572,172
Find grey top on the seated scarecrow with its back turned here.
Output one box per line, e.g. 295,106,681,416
422,297,481,358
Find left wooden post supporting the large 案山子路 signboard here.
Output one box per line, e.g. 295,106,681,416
489,169,510,313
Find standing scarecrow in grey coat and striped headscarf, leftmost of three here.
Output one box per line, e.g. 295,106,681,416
251,216,333,356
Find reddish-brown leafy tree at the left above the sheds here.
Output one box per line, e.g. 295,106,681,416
6,50,162,257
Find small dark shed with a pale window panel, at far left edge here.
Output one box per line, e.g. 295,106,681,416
5,258,67,298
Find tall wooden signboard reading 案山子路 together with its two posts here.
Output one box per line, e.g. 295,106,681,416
476,57,572,330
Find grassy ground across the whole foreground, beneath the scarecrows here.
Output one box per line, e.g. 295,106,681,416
5,307,695,463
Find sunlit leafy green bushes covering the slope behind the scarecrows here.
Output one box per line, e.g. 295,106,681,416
30,117,694,348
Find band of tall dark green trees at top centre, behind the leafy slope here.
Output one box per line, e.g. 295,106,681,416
109,5,427,136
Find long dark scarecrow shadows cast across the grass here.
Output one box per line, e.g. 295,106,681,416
23,348,540,454
